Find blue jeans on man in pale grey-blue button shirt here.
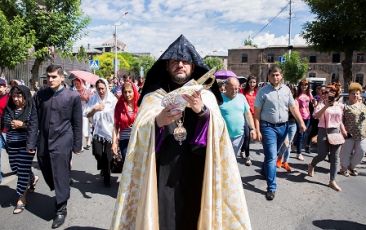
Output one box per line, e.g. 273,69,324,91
260,121,288,192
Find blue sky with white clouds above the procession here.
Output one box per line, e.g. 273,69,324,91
75,0,314,58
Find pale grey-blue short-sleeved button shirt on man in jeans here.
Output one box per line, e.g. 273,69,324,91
254,84,295,124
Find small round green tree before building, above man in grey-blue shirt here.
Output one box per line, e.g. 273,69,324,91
278,51,309,84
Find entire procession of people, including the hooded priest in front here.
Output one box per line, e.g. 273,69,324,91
0,35,366,229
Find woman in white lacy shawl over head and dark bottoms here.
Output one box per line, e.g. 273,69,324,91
85,78,117,187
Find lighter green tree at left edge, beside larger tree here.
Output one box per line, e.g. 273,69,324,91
0,10,35,76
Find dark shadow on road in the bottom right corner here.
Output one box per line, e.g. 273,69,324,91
313,220,366,230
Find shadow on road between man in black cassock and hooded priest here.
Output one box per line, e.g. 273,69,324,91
71,170,118,199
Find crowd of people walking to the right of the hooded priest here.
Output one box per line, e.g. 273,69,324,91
220,66,366,200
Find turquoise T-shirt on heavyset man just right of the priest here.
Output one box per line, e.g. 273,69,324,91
220,94,249,138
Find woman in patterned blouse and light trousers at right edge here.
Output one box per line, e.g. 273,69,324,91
339,82,366,176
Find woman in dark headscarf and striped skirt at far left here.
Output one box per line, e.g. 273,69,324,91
4,85,38,214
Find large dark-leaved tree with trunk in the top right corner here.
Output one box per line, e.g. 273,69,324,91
303,0,366,88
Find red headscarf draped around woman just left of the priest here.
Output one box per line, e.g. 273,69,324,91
114,81,140,129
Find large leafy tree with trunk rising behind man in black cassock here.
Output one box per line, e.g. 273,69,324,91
2,0,89,90
